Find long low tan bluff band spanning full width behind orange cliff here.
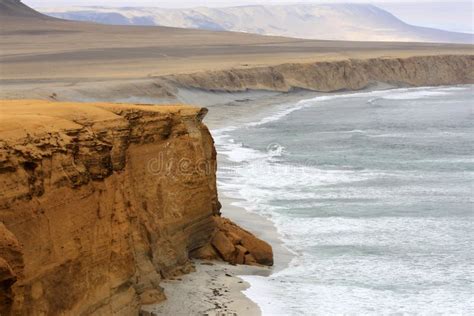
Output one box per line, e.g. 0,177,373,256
0,54,474,105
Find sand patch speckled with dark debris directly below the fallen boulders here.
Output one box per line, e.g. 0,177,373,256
140,260,269,316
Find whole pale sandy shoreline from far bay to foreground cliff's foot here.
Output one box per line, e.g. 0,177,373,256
146,84,472,315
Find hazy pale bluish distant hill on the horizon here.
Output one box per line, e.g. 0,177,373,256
40,4,473,43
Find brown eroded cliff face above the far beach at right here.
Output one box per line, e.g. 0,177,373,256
169,55,474,92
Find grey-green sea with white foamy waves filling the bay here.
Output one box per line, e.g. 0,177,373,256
213,86,474,315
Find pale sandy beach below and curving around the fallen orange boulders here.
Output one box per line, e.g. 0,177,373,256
143,195,292,316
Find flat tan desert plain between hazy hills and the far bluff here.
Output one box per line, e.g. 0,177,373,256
0,16,474,80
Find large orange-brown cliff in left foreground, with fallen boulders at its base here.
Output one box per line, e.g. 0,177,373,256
0,100,273,315
